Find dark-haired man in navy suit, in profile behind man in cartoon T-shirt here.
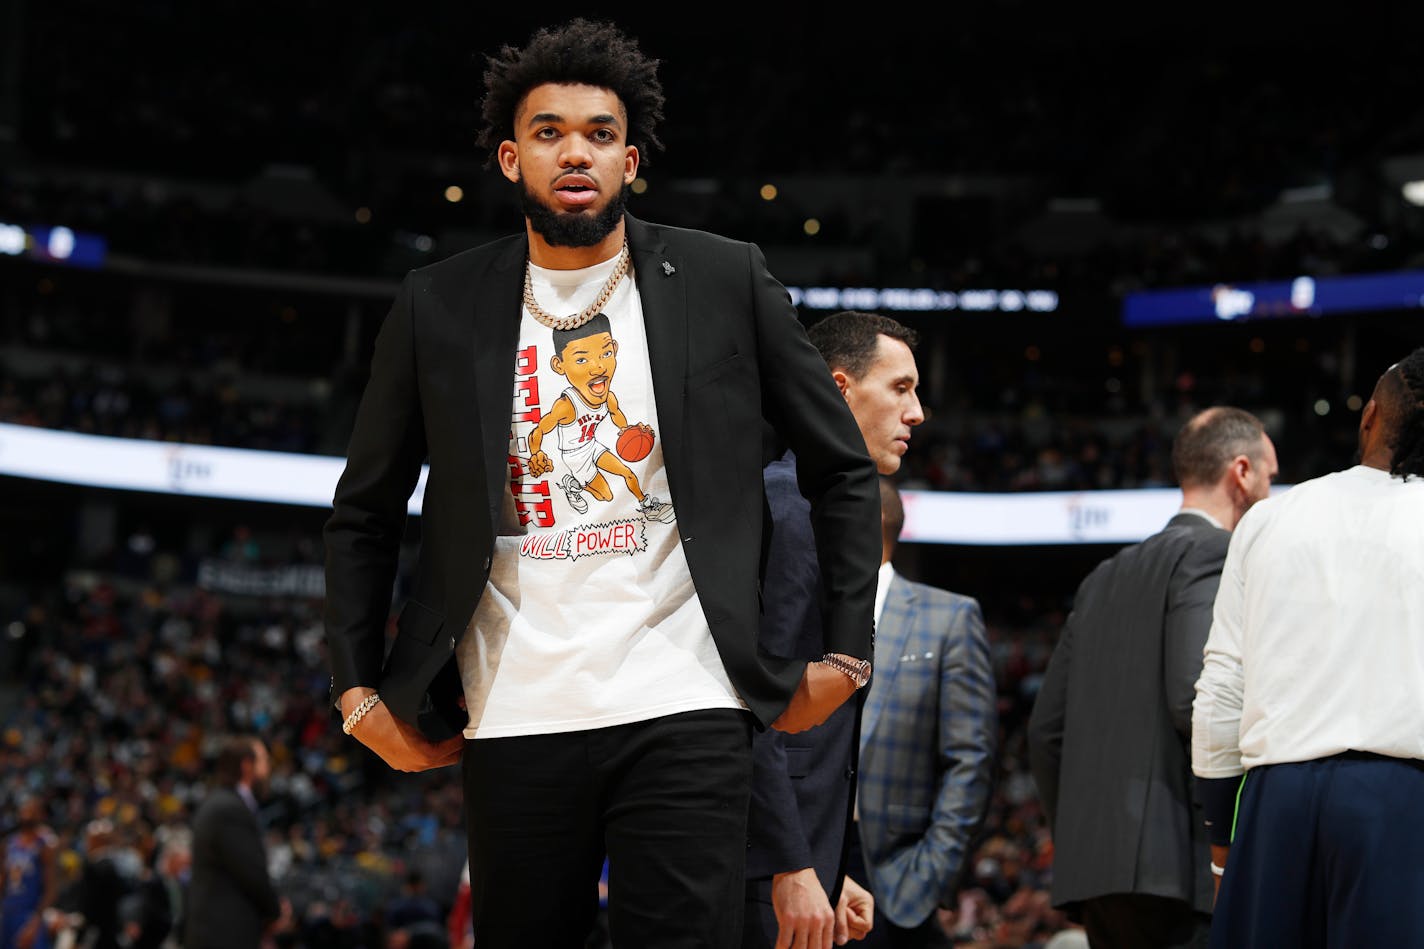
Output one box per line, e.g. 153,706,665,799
742,311,924,949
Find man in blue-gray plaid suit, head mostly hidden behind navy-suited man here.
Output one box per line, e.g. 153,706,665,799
847,476,998,949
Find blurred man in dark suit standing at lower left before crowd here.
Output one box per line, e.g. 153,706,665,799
182,735,290,949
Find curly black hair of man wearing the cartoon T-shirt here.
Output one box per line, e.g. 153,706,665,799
476,17,664,165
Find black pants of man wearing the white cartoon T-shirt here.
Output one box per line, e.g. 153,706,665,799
464,710,752,949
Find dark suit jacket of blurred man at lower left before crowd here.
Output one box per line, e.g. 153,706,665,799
182,788,281,949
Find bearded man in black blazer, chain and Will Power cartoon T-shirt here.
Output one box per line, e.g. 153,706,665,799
325,19,877,949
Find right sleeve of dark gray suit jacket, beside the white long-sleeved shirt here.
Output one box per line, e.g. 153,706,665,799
1162,529,1230,741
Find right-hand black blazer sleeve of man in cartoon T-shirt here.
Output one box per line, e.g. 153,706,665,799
748,245,880,658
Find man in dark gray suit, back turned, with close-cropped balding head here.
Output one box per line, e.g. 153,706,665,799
1028,406,1276,949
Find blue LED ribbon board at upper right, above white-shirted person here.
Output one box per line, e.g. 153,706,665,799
1122,271,1424,326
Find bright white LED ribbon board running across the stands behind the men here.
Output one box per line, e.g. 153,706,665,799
0,423,1286,546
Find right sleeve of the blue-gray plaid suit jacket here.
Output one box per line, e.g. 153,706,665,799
918,594,998,906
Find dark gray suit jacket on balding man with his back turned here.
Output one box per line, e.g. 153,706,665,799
1028,514,1230,912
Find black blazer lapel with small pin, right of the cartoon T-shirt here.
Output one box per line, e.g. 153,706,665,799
624,214,691,519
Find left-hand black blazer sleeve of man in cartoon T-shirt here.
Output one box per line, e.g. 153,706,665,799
323,275,426,702
